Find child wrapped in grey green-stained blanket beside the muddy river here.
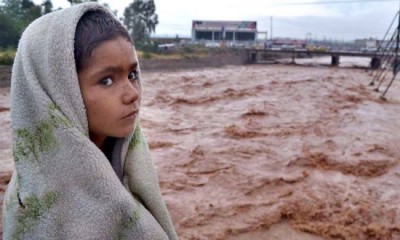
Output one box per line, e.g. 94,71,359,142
3,3,177,239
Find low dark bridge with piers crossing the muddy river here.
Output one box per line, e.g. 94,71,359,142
246,48,382,69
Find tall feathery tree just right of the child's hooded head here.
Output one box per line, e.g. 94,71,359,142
123,0,158,46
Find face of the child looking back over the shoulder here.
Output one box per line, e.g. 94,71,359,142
78,37,141,147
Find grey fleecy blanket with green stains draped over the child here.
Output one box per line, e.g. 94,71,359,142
3,3,177,239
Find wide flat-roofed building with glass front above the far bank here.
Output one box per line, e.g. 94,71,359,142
192,20,257,43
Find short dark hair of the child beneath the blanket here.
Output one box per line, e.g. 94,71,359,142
74,10,132,71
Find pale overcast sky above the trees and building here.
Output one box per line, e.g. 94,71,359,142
34,0,400,40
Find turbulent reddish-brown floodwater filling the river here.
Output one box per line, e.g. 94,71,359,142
0,57,400,240
